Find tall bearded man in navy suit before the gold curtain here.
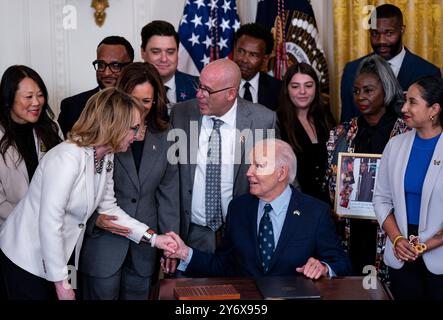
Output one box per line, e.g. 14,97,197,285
340,4,440,122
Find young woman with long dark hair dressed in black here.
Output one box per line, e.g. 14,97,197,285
277,63,335,202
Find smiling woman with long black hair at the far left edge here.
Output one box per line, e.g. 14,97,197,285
0,65,62,299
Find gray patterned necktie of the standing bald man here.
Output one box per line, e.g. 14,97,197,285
205,118,223,231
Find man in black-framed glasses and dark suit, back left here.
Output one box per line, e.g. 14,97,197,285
58,36,134,138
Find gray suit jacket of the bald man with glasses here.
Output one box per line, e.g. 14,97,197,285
171,98,278,240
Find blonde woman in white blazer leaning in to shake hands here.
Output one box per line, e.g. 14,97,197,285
0,88,175,299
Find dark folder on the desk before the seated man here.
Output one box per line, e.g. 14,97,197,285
255,276,321,300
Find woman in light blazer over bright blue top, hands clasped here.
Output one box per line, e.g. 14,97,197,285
373,77,443,299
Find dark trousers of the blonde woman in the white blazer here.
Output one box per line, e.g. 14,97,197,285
0,250,57,300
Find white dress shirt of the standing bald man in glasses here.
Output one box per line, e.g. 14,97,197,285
191,100,237,226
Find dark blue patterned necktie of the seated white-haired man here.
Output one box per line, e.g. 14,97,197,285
258,203,275,273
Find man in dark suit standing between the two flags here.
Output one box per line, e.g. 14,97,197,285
234,23,281,110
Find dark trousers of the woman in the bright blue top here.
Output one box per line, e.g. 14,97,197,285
389,225,443,300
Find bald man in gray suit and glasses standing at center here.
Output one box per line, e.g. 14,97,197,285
170,59,277,253
